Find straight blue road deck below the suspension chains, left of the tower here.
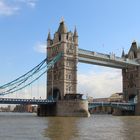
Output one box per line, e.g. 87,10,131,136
0,98,56,105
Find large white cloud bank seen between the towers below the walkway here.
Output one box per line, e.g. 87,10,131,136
78,69,122,98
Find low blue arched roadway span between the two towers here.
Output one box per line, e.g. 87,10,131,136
88,102,135,111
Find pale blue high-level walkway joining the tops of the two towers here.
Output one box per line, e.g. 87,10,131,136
78,49,140,69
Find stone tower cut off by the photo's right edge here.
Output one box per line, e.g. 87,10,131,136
122,41,140,115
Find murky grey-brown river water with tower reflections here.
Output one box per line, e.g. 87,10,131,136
0,113,140,140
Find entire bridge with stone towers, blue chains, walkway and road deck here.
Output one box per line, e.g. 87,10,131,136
0,21,140,116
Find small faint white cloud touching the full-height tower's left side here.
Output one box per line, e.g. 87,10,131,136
34,42,46,53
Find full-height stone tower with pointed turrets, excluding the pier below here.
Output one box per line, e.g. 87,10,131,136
47,20,78,100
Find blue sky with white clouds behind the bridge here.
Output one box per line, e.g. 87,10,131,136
0,0,140,98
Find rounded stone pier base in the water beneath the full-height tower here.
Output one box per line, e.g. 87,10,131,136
37,100,90,117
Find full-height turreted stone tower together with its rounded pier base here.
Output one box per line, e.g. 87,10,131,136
38,21,89,117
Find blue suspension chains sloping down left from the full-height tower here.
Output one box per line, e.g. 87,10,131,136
0,53,63,95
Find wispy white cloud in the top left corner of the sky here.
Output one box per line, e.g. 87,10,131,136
0,0,37,16
